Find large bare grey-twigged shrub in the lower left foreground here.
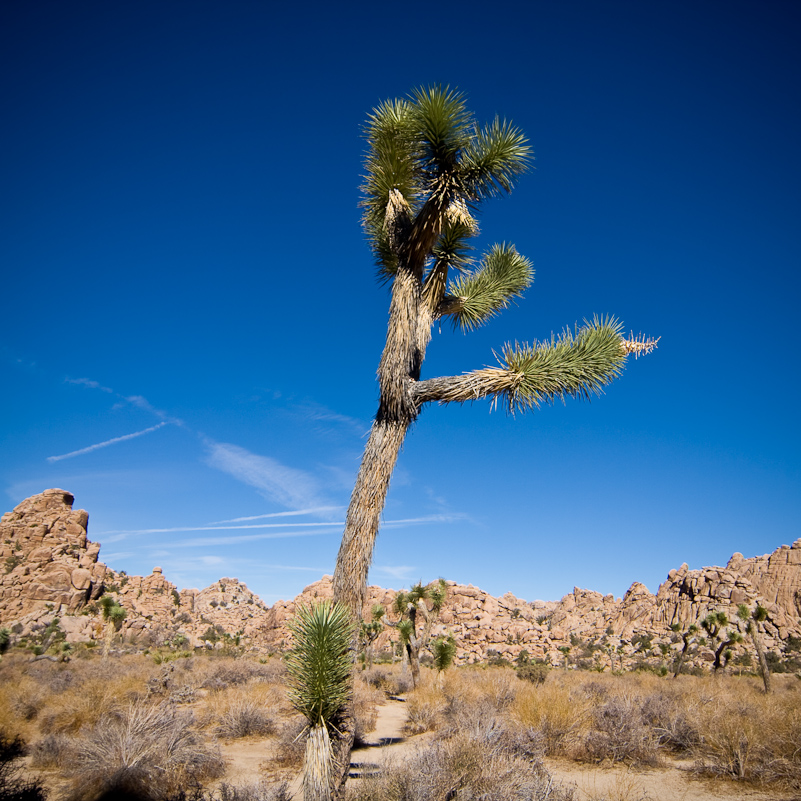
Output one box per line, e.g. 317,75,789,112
60,701,224,801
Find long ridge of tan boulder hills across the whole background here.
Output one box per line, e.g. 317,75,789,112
0,489,801,667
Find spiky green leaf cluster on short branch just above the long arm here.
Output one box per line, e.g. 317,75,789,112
448,242,534,331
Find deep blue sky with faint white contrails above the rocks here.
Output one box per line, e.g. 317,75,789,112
0,0,801,603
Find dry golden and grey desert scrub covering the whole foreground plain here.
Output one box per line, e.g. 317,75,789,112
0,648,801,801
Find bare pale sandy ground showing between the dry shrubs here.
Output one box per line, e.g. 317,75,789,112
216,701,801,801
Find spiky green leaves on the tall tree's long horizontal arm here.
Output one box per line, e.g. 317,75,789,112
502,317,626,411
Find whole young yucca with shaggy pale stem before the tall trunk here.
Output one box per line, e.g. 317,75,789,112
286,601,354,801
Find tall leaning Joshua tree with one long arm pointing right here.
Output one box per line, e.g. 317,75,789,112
334,87,656,617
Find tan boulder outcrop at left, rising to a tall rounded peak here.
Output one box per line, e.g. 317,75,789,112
0,489,267,645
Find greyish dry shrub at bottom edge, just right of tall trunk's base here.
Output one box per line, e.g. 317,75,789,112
346,732,573,801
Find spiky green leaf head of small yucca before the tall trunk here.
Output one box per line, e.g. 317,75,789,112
286,601,353,726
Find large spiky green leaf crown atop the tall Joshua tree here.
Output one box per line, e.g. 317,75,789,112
362,86,531,278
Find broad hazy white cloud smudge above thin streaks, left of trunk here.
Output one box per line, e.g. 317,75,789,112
203,437,319,508
